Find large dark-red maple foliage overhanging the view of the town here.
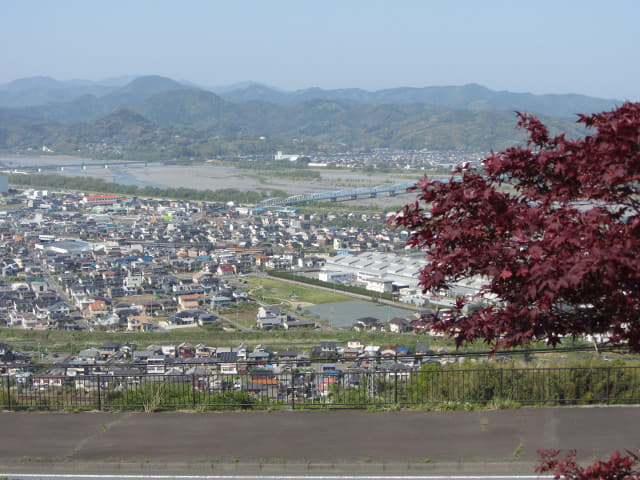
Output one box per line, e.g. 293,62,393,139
390,103,640,352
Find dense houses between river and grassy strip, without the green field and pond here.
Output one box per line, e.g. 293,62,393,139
0,178,456,354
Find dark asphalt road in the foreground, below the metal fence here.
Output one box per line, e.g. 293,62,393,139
0,407,640,478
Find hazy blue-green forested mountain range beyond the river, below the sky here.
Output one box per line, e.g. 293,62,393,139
0,76,620,159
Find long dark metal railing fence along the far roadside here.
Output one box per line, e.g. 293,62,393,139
0,366,640,411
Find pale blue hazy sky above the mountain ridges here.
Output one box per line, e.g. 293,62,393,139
0,0,640,101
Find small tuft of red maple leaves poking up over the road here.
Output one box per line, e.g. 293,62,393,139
536,450,640,480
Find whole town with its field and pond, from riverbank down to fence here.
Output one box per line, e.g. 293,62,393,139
0,177,636,407
